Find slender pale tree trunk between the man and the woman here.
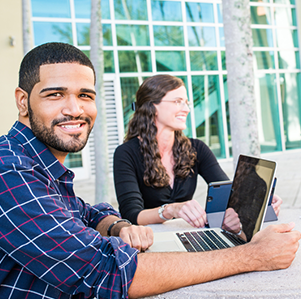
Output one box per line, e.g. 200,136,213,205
90,0,111,203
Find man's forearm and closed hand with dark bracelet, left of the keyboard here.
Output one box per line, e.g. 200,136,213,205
96,215,154,251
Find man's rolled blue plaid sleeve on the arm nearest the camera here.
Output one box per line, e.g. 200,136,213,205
0,165,137,298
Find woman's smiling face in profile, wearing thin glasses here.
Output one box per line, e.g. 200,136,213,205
154,86,190,131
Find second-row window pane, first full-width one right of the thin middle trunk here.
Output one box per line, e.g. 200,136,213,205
116,25,149,46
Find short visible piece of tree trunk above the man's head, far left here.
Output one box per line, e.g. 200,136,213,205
22,0,33,55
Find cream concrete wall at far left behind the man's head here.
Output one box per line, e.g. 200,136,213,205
0,0,23,135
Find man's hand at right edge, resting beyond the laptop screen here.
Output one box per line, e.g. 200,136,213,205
246,222,301,271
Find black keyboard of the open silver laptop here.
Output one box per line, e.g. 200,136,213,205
176,230,243,252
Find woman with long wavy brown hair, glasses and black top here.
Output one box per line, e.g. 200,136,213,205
114,75,278,233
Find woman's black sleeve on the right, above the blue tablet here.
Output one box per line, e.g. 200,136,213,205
192,139,229,184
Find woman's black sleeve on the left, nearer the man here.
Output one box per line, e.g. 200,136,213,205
114,144,144,224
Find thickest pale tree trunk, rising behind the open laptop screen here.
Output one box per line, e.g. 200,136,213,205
222,0,260,166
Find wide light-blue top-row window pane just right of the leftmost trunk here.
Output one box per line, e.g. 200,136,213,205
31,0,71,18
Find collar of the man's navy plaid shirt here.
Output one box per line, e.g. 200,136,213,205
9,121,68,180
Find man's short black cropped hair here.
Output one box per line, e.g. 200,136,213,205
19,42,95,97
